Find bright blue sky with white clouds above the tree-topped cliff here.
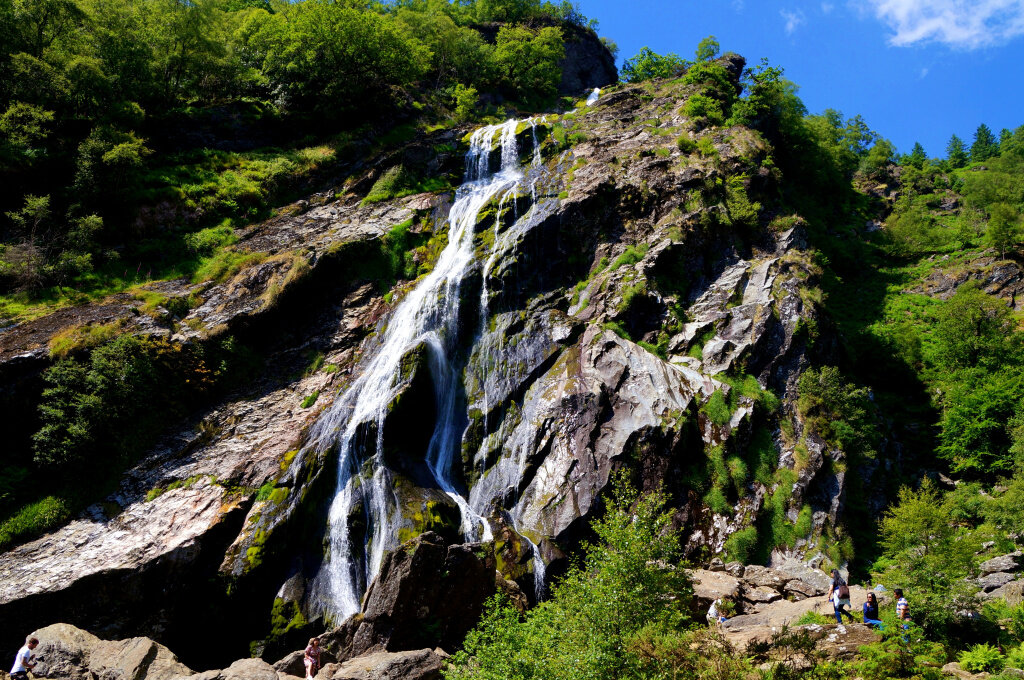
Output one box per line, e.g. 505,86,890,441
580,0,1024,156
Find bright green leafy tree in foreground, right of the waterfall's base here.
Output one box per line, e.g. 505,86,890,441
444,477,692,680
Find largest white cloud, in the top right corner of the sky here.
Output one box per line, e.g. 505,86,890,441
857,0,1024,49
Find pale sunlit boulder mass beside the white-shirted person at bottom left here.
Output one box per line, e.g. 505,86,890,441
33,624,191,680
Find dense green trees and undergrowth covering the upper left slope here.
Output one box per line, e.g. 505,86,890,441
0,0,593,317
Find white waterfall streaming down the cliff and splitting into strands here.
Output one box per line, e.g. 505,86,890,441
306,115,544,622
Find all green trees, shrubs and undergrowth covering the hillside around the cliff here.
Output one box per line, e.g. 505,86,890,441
6,9,1024,680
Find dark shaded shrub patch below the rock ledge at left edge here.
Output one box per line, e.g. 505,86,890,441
0,335,256,549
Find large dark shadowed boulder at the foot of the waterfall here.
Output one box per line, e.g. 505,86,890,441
321,532,496,662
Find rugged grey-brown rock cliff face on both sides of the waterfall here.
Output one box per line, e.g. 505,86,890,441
0,65,845,668
